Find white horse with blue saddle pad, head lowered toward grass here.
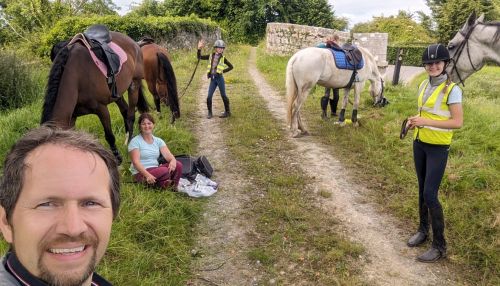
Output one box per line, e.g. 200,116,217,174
286,47,388,137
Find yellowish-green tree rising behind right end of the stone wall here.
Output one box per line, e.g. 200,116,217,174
352,11,434,44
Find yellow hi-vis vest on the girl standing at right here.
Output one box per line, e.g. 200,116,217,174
413,81,455,145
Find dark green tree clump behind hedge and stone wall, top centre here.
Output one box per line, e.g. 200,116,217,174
133,0,347,43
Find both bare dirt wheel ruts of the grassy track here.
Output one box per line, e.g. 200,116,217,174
190,49,457,285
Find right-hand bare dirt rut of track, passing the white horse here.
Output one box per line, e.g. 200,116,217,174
245,48,457,285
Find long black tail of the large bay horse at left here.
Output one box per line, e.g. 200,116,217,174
40,46,69,124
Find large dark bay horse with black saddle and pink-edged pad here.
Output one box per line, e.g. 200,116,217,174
41,32,148,163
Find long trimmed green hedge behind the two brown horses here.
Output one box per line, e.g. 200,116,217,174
37,16,224,56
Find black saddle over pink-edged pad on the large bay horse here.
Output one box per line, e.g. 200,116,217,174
83,25,120,97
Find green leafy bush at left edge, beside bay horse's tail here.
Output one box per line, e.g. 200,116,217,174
0,50,43,110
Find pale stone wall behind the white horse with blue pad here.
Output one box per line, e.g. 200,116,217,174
266,23,388,67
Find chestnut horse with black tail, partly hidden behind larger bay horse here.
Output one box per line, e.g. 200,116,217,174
139,38,181,123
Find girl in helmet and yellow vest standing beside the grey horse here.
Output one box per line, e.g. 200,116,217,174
407,44,463,262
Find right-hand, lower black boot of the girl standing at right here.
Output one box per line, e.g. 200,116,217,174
417,206,446,263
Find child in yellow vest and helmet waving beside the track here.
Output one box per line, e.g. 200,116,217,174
197,40,233,119
